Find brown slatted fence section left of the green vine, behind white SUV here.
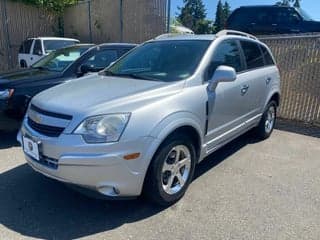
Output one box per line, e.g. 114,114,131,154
0,0,57,71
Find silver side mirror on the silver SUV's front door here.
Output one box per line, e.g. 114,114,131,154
208,66,237,91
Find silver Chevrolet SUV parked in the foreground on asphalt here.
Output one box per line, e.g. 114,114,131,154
18,31,280,205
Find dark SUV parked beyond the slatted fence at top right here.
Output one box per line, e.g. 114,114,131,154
226,6,320,35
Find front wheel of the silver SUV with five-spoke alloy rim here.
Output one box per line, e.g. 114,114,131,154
144,134,196,206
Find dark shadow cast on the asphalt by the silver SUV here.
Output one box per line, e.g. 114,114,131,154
0,134,255,240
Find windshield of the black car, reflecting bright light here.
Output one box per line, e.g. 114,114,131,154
31,46,89,72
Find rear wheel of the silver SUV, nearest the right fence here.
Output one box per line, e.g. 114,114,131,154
255,101,277,140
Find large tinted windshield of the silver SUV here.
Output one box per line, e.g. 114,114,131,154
101,40,211,82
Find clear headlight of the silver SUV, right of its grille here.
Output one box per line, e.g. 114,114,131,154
74,113,130,143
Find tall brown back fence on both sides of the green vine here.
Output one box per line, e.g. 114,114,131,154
0,0,167,71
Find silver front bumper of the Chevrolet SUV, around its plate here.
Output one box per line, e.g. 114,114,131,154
17,119,157,197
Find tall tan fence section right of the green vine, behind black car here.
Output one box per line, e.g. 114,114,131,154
64,0,167,43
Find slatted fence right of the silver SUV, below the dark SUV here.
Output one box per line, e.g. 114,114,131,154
261,35,320,125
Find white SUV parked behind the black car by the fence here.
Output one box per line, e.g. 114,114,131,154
18,37,80,68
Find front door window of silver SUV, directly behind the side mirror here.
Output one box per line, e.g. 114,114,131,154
208,40,243,77
